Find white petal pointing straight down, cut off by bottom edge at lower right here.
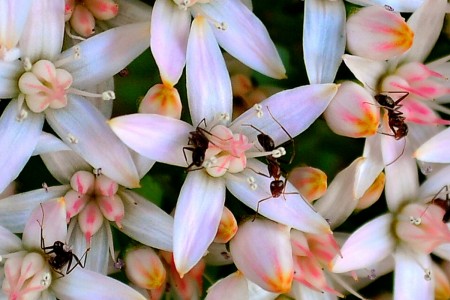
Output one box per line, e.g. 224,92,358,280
393,249,434,300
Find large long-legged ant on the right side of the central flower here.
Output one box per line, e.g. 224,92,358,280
243,106,298,214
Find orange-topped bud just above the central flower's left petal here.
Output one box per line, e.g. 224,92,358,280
139,84,182,119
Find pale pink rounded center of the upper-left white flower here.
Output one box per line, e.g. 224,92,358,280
19,60,73,113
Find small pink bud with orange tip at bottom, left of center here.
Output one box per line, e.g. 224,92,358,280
125,247,166,290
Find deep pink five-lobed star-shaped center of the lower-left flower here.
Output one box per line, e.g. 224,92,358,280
65,170,125,242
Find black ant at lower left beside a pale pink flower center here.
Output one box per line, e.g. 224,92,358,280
36,203,90,278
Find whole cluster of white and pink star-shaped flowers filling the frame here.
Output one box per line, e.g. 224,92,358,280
0,0,450,300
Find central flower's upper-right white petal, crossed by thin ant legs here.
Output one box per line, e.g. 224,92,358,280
230,84,338,145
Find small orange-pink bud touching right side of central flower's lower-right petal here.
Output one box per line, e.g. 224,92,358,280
289,167,327,202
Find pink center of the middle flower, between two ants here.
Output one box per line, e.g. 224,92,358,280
203,125,253,177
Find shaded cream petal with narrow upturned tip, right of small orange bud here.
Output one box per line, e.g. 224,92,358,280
314,157,365,228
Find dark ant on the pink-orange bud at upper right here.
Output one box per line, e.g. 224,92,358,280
374,91,409,166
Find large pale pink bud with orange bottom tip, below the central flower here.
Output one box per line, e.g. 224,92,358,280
230,218,294,293
